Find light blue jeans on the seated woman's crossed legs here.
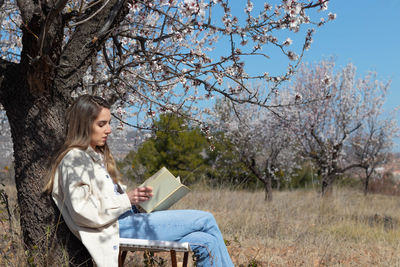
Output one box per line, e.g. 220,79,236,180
118,210,233,267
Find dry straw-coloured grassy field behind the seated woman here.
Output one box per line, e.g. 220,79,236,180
0,183,400,267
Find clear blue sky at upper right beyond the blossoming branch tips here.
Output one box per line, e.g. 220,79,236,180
216,0,400,152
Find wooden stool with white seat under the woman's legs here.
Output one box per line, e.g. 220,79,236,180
118,238,191,267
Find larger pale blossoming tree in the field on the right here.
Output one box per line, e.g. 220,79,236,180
286,60,397,194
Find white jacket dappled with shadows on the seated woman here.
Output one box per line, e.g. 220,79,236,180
52,146,132,267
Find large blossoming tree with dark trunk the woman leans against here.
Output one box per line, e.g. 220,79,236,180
0,0,335,265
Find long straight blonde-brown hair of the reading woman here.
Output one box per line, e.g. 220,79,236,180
44,95,120,194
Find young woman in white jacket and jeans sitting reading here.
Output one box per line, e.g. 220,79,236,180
45,95,233,267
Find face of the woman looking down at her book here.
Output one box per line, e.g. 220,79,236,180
90,108,111,149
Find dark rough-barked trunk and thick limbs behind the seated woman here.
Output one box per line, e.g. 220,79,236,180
0,0,127,266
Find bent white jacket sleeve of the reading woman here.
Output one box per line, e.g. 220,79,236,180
59,149,131,228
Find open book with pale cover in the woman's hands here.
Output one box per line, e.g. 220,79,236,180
139,167,190,213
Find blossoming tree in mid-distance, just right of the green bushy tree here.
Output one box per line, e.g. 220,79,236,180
215,94,298,201
